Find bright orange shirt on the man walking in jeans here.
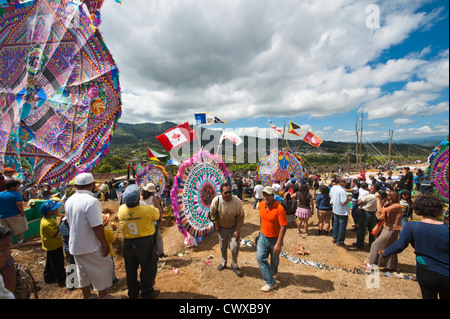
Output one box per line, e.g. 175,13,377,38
259,201,287,238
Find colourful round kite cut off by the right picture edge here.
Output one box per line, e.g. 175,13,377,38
428,136,449,203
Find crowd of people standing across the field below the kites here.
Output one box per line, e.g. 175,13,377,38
0,167,449,299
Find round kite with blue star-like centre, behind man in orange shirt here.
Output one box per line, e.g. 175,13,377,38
258,149,304,186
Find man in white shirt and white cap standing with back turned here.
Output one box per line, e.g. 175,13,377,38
65,173,113,299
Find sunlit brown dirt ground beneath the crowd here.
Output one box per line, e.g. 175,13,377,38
12,186,421,300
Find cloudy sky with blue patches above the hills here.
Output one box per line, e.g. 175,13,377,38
100,0,449,141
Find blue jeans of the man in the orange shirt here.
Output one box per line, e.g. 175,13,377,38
256,232,280,286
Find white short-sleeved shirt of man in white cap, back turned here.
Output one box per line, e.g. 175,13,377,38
65,190,103,255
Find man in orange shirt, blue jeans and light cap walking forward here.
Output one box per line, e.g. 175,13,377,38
256,186,288,292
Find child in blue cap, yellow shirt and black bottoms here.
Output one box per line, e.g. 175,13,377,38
40,200,66,287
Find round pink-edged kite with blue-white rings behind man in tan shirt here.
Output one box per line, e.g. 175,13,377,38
171,150,231,245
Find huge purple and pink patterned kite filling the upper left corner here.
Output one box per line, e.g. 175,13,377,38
0,0,121,185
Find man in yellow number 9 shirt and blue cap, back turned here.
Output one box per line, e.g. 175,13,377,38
118,184,160,299
